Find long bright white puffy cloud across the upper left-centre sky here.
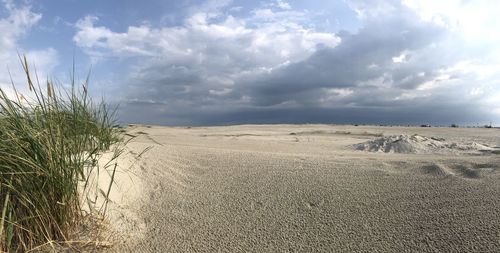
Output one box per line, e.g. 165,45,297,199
73,4,339,62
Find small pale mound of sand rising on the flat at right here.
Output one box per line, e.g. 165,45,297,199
355,134,496,154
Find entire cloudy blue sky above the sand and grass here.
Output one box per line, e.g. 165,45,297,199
0,0,500,126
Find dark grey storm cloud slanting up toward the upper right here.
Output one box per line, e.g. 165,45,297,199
242,9,446,105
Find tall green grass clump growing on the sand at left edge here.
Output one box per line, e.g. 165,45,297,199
0,58,121,252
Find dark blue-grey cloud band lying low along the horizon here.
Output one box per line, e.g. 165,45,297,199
121,104,496,126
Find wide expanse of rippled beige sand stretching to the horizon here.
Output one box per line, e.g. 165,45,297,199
106,125,500,252
